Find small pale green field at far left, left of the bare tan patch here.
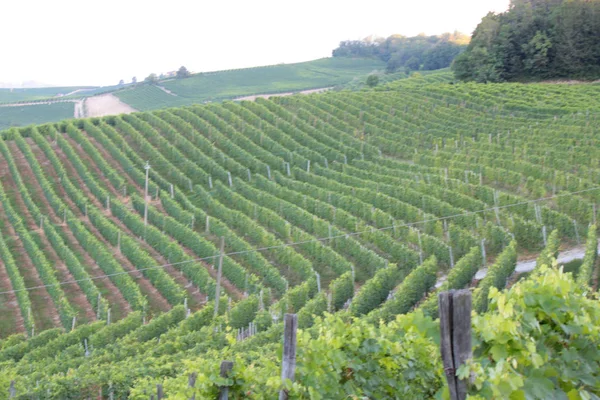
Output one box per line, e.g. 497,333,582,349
0,102,74,130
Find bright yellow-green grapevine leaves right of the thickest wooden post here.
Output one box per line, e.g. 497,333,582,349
466,266,600,399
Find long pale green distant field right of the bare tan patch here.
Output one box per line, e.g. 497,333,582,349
115,58,385,110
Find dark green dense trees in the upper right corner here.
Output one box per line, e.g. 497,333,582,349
453,0,600,82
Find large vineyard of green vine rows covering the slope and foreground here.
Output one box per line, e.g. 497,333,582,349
0,73,600,399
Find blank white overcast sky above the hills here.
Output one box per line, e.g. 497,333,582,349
0,0,509,85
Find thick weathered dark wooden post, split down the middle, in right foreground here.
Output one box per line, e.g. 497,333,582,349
438,289,472,400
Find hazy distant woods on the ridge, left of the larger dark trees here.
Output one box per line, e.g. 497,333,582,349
332,32,469,72
